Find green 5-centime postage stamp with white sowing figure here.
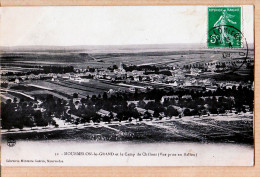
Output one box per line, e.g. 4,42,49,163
208,7,242,48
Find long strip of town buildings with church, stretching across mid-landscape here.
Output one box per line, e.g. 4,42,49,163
1,63,253,92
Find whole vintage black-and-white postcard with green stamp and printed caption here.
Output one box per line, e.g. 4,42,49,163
0,5,255,166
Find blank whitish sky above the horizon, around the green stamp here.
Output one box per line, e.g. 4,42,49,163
0,6,254,47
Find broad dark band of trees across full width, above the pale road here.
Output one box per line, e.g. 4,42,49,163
1,82,254,128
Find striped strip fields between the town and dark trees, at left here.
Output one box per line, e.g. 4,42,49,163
1,79,130,101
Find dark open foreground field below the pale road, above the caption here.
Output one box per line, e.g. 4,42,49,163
3,116,254,145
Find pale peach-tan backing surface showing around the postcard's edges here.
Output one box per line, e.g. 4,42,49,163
0,0,260,177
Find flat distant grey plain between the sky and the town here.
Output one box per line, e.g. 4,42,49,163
0,45,254,71
